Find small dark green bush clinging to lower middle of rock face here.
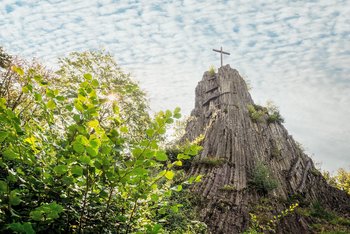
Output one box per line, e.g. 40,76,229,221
250,162,278,195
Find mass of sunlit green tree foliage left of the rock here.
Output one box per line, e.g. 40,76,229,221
0,59,204,233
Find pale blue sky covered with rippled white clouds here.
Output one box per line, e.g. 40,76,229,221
0,0,350,171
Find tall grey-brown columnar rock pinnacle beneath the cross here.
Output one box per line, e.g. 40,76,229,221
182,65,350,233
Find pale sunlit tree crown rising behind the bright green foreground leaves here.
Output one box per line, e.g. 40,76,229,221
55,51,149,140
